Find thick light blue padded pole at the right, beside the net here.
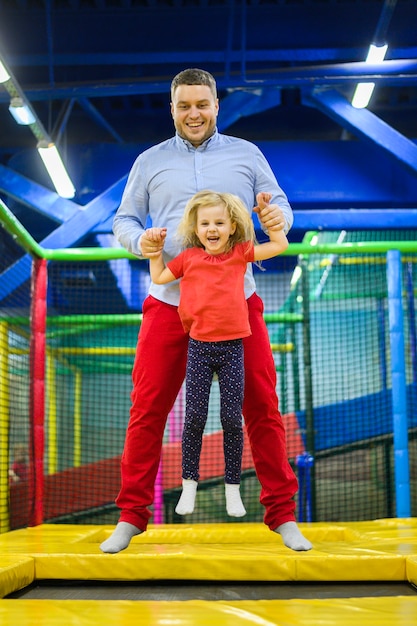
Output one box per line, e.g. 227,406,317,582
387,250,411,517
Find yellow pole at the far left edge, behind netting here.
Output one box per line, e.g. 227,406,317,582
0,322,10,533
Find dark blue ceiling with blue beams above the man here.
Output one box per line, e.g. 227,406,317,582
0,0,417,308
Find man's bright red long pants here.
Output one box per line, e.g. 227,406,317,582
116,294,298,530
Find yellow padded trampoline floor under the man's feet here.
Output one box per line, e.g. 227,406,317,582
0,518,417,626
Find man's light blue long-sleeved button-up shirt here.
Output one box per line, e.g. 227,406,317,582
113,130,293,305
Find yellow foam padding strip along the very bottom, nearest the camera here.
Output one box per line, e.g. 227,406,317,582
0,596,417,626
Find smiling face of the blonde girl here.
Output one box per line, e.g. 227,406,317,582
195,204,236,255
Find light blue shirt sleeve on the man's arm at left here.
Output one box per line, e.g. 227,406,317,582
113,155,149,256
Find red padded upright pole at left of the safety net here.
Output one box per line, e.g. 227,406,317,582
29,259,48,526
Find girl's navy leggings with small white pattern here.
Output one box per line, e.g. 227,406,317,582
182,338,244,485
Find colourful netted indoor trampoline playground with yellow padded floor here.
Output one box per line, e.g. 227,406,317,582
0,201,417,626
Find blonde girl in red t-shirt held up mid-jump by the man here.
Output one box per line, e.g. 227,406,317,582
146,190,288,517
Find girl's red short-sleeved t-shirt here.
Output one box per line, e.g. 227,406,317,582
167,242,254,341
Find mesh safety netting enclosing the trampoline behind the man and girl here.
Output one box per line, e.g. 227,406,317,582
0,213,417,528
